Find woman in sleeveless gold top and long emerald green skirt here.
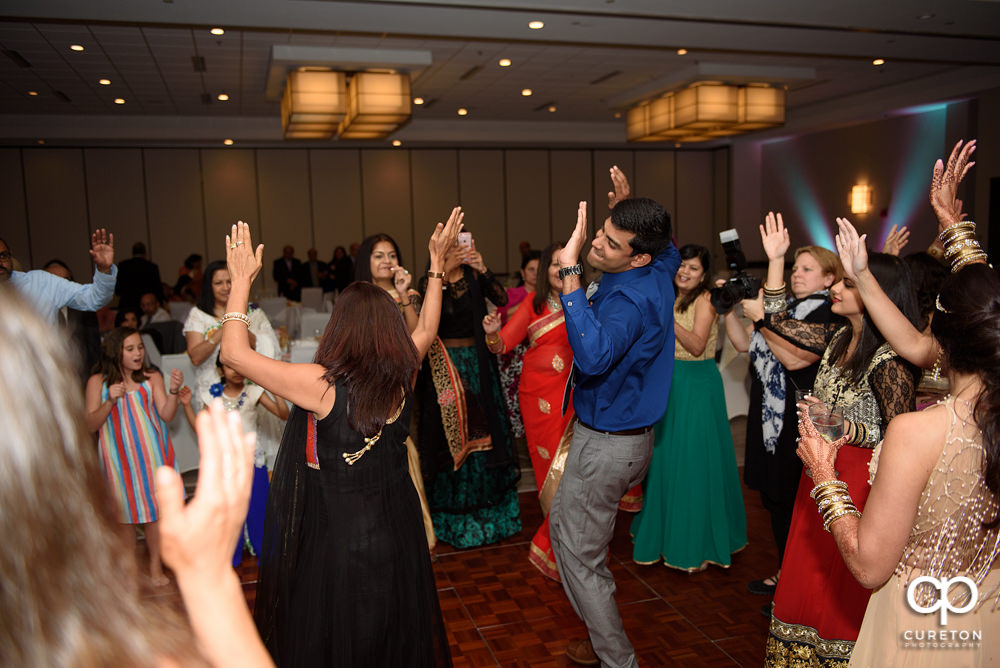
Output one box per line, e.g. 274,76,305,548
631,244,747,571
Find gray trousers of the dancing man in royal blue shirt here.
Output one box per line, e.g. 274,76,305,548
549,421,653,668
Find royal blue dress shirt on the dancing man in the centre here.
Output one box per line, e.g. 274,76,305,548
562,243,681,431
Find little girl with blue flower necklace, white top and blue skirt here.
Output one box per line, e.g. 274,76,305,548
181,355,289,568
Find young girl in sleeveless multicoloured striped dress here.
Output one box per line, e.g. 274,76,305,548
86,327,184,587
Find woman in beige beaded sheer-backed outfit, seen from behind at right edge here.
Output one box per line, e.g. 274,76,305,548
800,264,1000,666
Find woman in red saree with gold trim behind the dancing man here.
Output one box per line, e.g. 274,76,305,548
483,243,574,581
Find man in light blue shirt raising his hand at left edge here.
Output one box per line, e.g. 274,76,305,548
0,230,118,324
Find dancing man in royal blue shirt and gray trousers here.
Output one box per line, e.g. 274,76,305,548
549,167,681,668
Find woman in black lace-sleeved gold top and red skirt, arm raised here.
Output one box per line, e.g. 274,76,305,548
761,213,918,666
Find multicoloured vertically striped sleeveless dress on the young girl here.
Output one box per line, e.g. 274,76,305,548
98,381,176,524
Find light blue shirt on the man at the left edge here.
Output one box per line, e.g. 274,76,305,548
10,265,118,324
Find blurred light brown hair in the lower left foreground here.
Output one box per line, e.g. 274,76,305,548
0,286,203,667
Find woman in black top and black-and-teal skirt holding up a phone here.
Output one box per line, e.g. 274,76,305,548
417,235,521,548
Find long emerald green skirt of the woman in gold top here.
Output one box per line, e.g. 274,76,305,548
632,360,747,571
